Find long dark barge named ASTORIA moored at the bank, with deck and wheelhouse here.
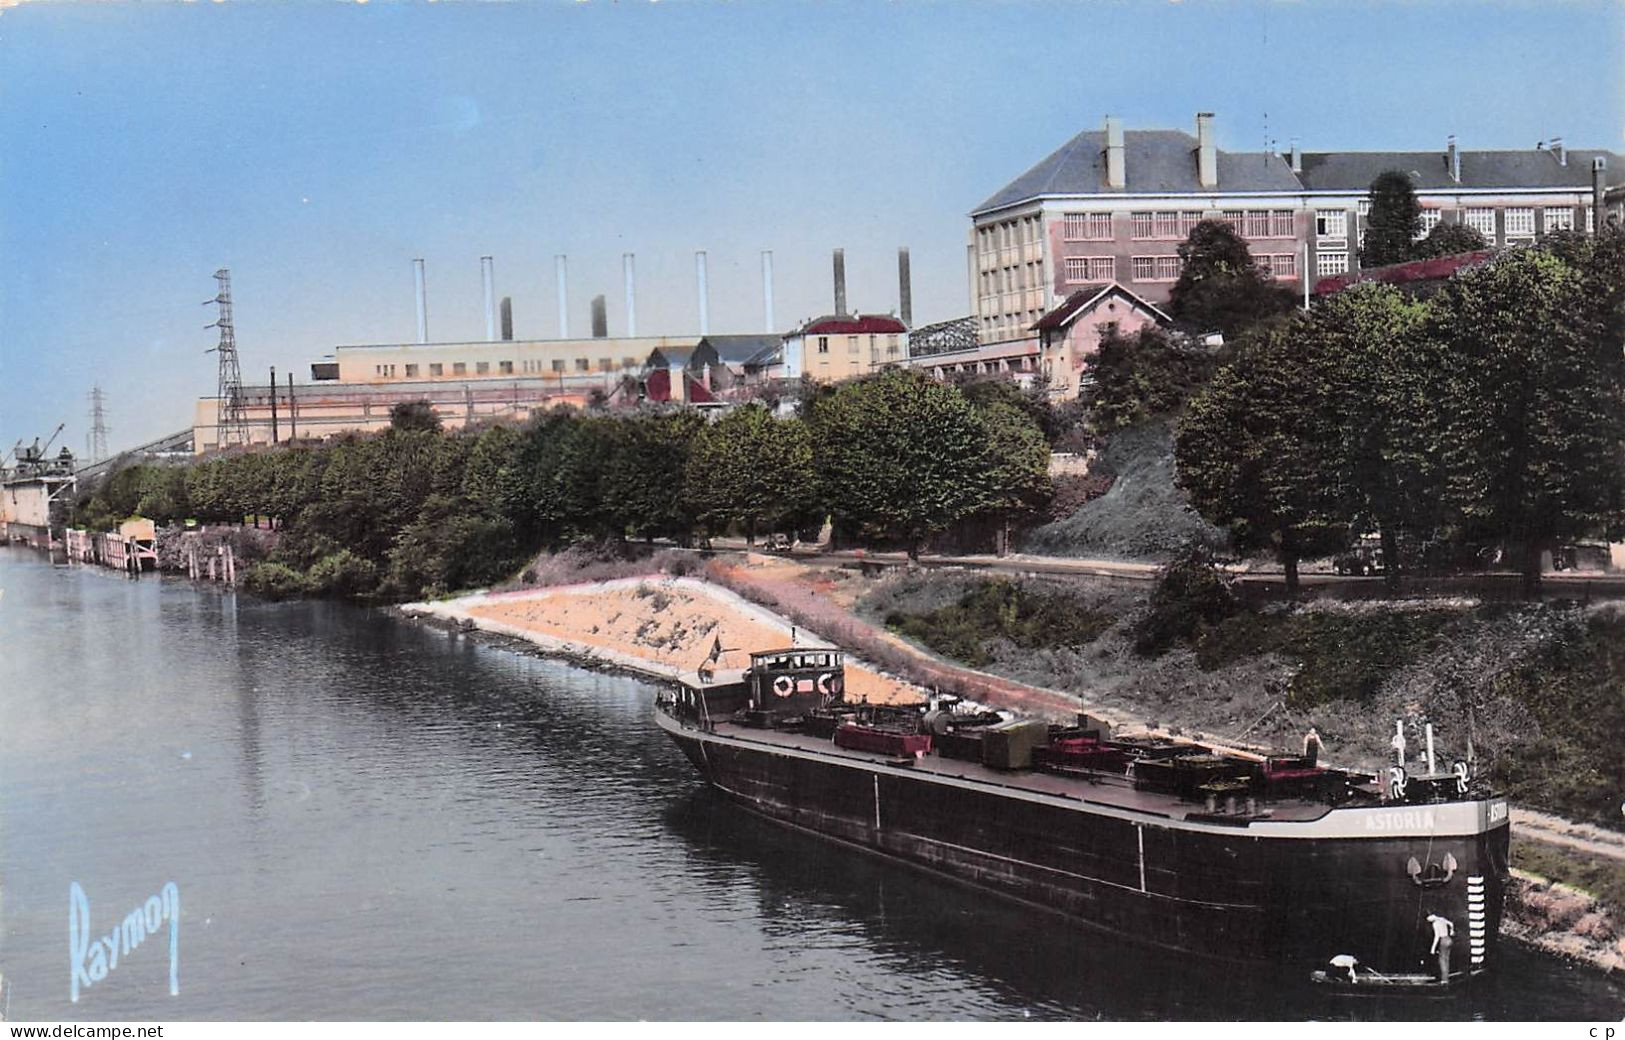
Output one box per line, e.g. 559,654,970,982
657,648,1510,991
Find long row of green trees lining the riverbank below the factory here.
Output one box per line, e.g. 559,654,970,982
76,371,1050,598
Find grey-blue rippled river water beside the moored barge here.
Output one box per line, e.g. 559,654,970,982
0,549,1625,1021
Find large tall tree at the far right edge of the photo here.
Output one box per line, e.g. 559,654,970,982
1428,250,1625,596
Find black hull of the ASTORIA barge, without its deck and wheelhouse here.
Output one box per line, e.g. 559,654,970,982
660,717,1508,977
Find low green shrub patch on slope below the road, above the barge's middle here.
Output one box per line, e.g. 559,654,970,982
886,580,1113,668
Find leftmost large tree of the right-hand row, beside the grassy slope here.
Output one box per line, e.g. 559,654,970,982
1173,319,1347,595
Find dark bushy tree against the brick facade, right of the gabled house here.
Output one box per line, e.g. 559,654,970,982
1168,219,1294,338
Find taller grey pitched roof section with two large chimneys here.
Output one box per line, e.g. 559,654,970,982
973,130,1298,213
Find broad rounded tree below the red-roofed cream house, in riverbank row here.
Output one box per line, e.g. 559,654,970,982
808,369,995,557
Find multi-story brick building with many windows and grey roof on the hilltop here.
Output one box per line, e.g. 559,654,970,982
967,114,1625,345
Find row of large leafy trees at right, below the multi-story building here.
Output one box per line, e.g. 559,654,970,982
1175,232,1625,590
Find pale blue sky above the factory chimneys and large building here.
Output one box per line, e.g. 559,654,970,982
0,0,1625,452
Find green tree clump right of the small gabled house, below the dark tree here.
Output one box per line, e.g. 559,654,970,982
1081,322,1217,436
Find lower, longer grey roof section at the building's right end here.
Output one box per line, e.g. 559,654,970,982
1303,148,1625,192
